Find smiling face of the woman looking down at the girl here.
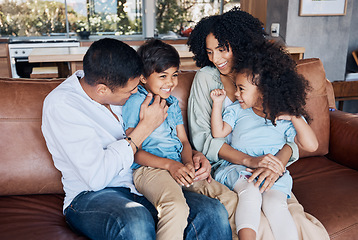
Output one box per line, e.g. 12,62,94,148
206,33,234,75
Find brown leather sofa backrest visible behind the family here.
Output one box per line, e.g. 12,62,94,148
0,59,334,195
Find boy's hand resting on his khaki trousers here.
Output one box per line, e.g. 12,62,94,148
168,161,195,187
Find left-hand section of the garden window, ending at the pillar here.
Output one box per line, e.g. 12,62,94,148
0,0,142,36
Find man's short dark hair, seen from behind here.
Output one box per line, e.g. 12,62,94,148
83,38,143,91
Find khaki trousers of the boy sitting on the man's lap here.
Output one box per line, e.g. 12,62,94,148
133,166,238,240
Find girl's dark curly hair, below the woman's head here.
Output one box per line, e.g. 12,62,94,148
234,41,311,125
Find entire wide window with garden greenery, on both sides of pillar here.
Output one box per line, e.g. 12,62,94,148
0,0,240,37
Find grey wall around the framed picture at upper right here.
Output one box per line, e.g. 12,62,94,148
266,0,358,113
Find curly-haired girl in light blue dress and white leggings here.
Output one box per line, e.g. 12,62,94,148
210,43,318,240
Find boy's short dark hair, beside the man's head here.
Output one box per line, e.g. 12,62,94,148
137,39,180,78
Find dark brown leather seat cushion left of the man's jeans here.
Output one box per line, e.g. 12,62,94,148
0,194,87,240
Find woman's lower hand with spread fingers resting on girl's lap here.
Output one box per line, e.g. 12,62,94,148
246,167,279,193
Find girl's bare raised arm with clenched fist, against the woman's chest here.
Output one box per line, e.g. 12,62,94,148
210,89,232,138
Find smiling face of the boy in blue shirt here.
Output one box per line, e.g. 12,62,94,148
141,67,178,99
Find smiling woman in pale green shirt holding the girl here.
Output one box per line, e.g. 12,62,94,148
188,8,328,240
